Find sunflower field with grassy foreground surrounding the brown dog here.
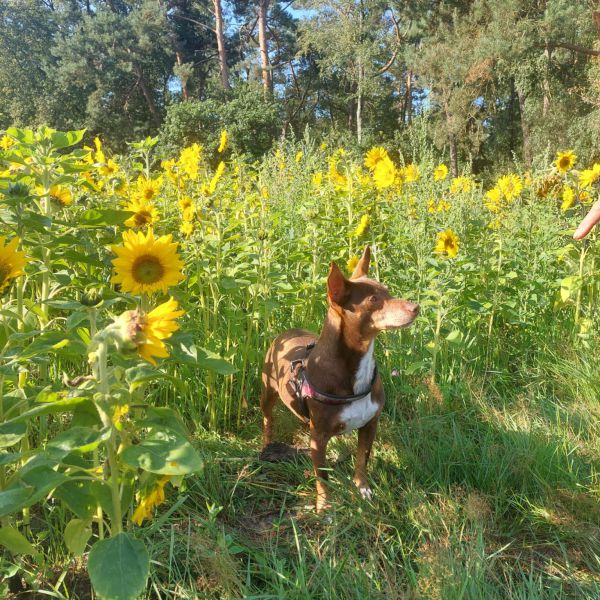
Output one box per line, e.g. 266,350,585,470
0,128,600,599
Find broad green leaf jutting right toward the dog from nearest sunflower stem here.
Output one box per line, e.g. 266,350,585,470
121,431,202,475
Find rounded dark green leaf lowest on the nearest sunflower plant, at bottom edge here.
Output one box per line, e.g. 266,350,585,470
88,533,150,600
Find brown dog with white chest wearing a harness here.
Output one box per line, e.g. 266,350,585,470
260,247,419,512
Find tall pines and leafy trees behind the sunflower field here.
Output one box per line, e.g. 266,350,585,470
0,0,600,172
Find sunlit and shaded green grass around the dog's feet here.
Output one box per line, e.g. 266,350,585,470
136,354,600,599
